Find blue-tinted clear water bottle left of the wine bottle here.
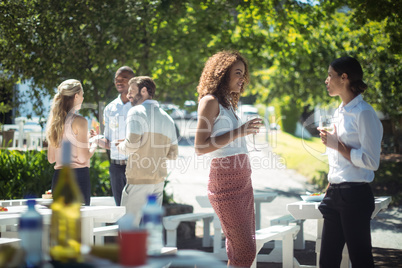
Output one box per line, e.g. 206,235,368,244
19,199,43,268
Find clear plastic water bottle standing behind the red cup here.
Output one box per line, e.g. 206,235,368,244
142,195,163,256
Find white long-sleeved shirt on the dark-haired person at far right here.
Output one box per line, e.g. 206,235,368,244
328,95,383,184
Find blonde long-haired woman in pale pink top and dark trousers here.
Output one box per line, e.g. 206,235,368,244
46,79,96,206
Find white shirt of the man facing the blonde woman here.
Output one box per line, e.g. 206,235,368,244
103,94,132,160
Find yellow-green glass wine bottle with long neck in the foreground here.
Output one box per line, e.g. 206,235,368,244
50,140,83,262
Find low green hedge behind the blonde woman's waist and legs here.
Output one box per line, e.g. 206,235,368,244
0,150,111,199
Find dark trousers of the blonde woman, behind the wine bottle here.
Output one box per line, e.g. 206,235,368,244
52,167,91,206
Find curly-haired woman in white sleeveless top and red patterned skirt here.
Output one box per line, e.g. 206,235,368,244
195,51,262,267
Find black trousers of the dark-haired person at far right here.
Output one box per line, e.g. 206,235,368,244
319,183,374,268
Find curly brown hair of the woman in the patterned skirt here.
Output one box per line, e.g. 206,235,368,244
197,51,249,109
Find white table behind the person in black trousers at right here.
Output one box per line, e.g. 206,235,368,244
286,196,392,268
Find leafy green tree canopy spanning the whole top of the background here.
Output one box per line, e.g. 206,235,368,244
0,0,402,136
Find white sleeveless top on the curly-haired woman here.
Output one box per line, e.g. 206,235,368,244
209,101,248,158
